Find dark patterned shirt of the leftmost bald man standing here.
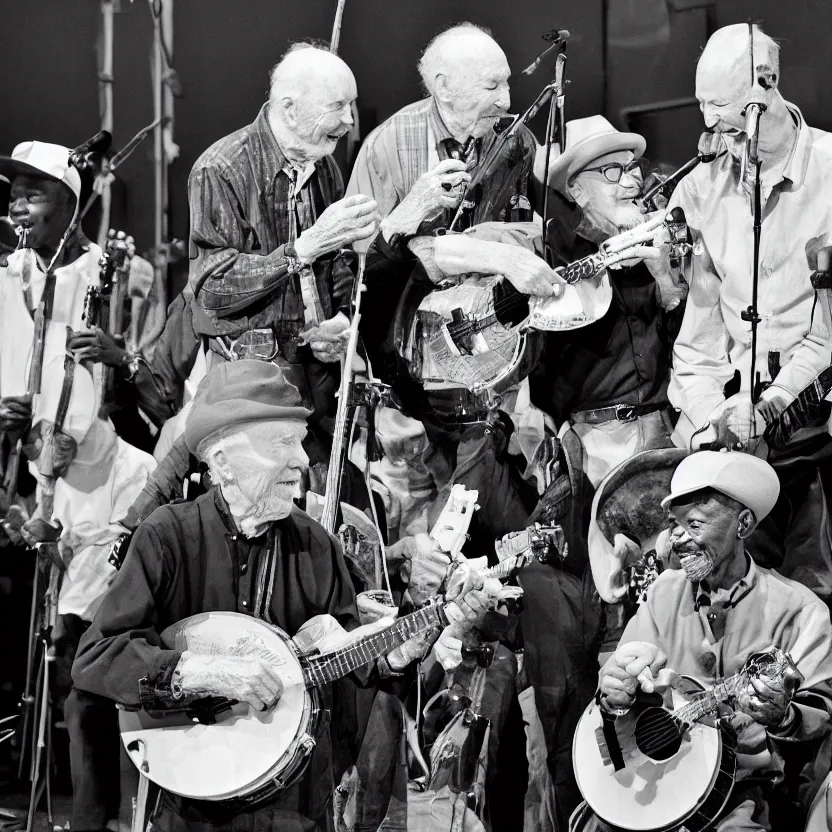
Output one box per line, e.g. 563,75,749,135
188,104,353,340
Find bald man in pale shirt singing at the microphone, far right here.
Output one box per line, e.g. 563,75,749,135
668,24,832,601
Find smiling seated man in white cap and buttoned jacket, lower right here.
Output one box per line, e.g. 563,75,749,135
582,451,832,832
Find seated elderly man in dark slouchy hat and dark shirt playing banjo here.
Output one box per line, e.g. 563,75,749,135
73,360,490,832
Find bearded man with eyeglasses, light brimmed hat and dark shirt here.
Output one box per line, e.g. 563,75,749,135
531,116,685,494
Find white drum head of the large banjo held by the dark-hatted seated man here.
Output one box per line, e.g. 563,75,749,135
119,612,315,800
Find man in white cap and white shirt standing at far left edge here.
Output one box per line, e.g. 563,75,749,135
0,141,148,830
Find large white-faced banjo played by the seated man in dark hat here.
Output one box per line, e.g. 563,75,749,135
119,485,532,808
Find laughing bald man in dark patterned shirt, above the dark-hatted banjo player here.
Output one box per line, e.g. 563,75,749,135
188,43,378,484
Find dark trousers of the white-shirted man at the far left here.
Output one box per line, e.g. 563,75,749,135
53,615,121,832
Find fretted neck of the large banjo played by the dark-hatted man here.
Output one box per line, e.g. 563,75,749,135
305,604,448,687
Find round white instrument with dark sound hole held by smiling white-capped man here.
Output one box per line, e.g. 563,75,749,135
572,648,794,832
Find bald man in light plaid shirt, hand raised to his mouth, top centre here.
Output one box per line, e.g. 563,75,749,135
347,23,558,544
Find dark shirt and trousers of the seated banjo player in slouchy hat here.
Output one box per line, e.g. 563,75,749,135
73,489,366,832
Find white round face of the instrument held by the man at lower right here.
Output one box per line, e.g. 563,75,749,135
572,680,727,832
